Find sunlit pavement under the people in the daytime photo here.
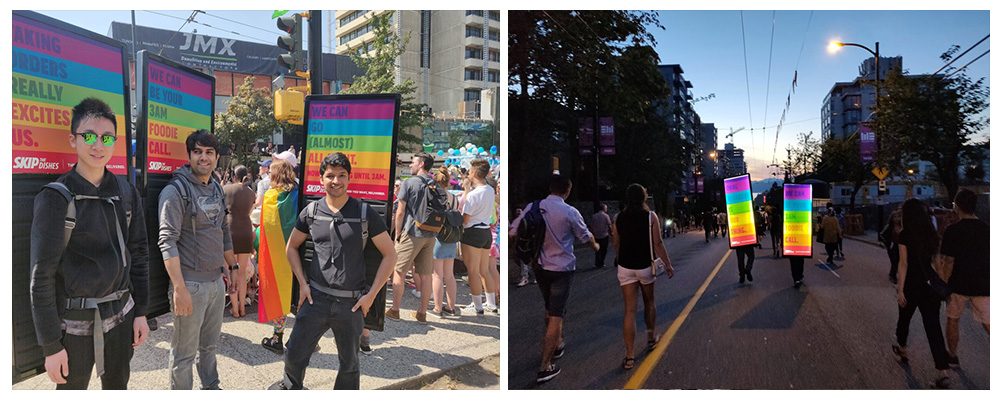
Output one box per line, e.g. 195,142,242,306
13,278,500,390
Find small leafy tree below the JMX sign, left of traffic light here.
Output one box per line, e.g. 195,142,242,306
215,76,291,166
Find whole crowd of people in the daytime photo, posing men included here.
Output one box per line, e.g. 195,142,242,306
31,98,499,389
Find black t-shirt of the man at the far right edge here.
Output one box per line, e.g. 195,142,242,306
941,219,990,296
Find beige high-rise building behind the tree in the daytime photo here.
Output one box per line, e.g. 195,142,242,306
334,10,501,119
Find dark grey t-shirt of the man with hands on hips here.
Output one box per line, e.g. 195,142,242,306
295,197,387,290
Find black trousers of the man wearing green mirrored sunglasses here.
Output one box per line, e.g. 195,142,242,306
56,311,135,390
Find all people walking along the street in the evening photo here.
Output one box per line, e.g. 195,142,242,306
508,174,990,388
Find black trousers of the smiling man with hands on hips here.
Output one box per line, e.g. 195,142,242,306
285,290,365,390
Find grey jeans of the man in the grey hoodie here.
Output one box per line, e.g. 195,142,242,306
167,275,226,390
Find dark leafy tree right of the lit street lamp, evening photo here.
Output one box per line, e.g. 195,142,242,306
873,58,990,202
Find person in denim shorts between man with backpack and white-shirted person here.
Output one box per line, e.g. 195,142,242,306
433,166,459,318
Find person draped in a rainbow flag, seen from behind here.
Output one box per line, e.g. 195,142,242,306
257,159,299,355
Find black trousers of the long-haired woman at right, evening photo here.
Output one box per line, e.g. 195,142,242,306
896,290,948,369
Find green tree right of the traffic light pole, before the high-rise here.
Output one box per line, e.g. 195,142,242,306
344,13,431,147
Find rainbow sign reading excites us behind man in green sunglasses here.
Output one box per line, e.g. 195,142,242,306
11,12,132,174
